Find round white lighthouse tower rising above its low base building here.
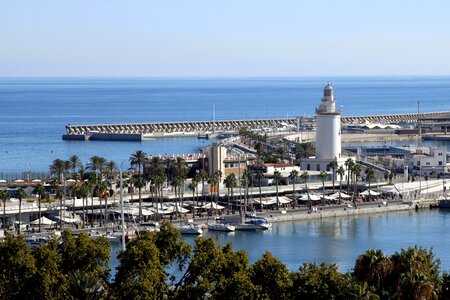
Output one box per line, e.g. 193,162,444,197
316,83,341,161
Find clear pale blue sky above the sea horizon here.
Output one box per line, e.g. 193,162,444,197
0,0,450,77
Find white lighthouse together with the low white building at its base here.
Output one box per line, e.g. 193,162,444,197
301,83,348,180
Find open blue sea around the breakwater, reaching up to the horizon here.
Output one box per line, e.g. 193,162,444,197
0,77,450,173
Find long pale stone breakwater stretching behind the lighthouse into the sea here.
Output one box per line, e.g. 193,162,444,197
63,111,450,139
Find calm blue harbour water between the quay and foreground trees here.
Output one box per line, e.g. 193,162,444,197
111,209,450,272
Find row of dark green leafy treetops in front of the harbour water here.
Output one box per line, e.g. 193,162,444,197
0,222,450,300
